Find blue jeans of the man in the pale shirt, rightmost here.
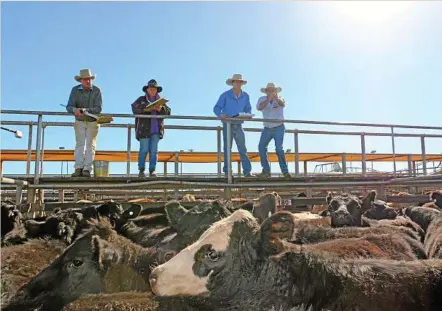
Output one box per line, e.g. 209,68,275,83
258,124,289,173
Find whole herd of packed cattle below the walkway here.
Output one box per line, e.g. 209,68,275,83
1,191,442,311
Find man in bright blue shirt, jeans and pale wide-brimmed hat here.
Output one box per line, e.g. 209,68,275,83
213,74,253,177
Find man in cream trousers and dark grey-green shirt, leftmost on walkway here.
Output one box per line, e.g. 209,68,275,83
66,69,102,177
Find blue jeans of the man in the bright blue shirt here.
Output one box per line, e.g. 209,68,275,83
223,123,252,176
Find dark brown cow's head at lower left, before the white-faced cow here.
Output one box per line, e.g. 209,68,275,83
3,221,155,311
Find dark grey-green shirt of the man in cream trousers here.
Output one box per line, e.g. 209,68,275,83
66,84,103,121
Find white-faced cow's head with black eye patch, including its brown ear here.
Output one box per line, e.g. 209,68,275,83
150,209,295,301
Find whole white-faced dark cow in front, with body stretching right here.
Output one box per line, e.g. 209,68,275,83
150,210,442,311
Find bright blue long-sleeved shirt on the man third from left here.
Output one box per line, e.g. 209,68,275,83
213,88,252,124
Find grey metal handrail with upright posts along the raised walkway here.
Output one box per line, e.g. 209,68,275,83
0,110,442,193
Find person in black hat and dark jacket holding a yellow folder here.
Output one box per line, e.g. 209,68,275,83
132,79,171,177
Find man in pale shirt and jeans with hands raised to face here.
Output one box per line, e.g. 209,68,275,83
256,83,291,178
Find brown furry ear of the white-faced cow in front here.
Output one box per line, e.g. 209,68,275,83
259,211,295,256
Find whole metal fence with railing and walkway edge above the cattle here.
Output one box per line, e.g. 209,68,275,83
1,110,442,207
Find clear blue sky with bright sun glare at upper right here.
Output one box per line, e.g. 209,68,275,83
1,1,442,174
